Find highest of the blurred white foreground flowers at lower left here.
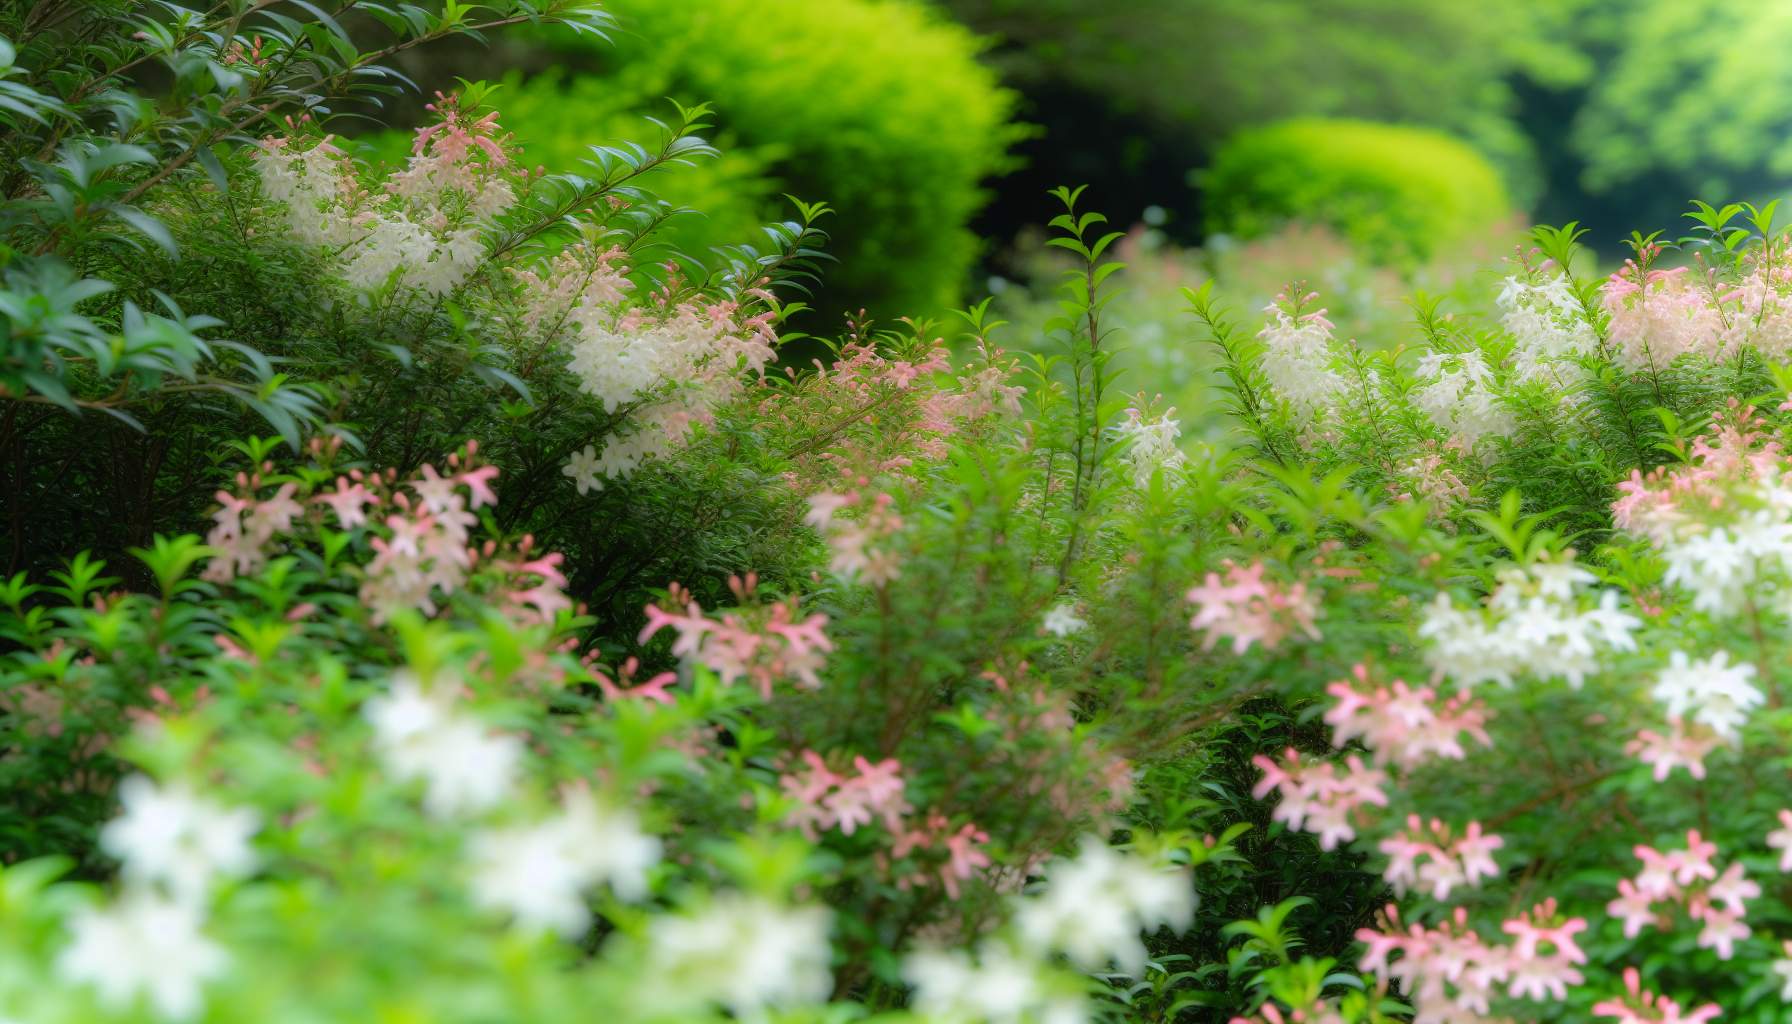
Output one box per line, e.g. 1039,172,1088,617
364,673,523,818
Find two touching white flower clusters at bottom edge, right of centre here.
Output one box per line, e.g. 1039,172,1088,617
903,837,1195,1024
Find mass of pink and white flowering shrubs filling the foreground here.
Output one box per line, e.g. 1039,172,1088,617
17,7,1792,1024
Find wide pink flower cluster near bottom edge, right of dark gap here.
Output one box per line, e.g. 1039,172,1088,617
1357,898,1586,1022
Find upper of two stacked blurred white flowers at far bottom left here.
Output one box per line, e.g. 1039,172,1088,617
100,775,260,900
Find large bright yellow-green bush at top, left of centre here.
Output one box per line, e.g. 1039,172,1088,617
505,0,1018,319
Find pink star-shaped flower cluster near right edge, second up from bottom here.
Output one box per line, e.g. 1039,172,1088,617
1606,830,1762,959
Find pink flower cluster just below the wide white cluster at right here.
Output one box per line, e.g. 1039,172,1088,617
1324,662,1493,768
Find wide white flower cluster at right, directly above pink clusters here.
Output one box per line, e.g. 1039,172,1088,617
1419,561,1641,689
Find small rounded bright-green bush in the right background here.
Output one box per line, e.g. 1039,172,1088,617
1199,118,1512,264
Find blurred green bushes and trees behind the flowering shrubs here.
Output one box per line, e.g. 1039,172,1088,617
367,0,1792,334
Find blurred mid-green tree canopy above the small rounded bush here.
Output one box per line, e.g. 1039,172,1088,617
946,0,1590,199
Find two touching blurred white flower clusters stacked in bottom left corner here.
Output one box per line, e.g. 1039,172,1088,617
56,777,258,1019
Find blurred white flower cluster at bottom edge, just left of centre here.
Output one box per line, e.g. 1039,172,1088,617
647,893,833,1015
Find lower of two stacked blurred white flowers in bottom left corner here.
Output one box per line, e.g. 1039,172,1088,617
56,889,228,1020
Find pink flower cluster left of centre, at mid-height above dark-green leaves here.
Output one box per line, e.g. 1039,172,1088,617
640,574,833,699
